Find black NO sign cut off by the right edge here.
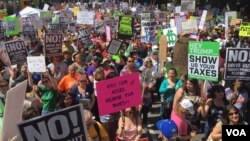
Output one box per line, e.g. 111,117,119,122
224,48,250,80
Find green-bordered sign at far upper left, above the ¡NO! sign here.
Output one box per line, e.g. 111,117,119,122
3,17,19,35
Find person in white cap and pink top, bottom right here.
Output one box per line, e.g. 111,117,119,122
171,99,196,141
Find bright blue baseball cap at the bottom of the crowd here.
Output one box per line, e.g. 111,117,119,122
156,119,178,138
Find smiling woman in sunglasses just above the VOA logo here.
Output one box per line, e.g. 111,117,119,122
208,104,247,141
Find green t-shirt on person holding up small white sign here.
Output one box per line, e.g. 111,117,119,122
38,87,56,112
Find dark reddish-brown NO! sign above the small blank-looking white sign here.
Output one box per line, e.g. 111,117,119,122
45,33,63,57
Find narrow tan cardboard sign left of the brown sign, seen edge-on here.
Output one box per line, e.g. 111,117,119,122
159,35,168,68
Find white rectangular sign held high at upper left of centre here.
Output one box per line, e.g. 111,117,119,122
76,11,95,25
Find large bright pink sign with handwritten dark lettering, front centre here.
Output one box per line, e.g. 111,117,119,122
96,73,142,116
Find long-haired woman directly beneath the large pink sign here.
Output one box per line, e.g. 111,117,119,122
117,107,142,141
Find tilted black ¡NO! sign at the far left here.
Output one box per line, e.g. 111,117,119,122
4,40,28,65
